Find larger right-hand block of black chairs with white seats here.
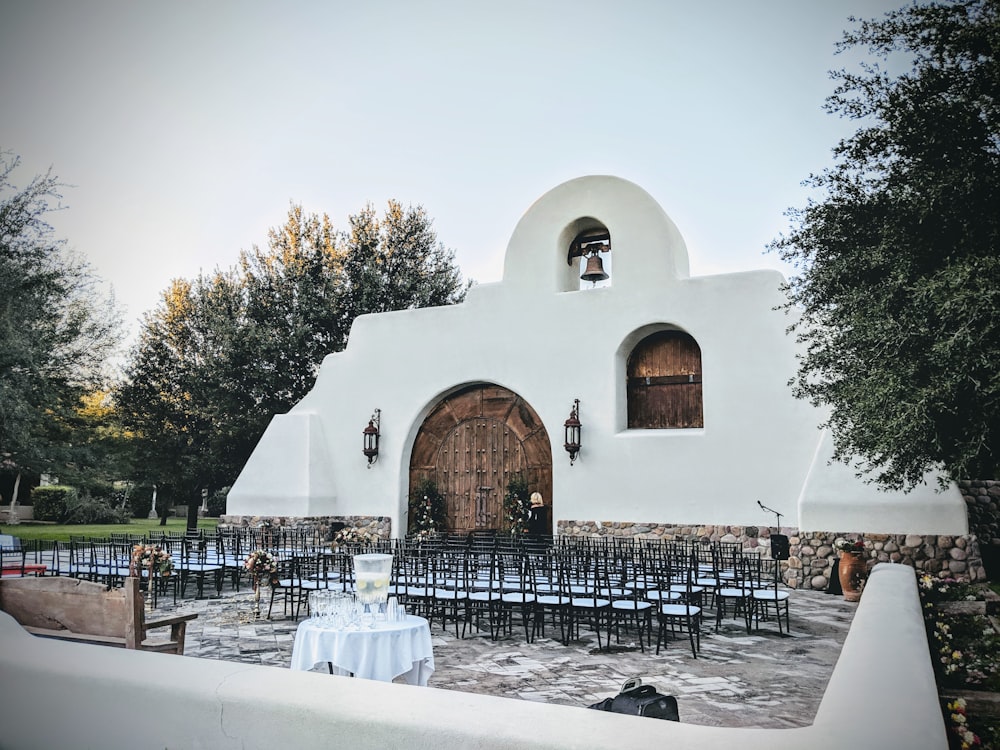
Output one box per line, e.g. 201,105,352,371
258,537,789,656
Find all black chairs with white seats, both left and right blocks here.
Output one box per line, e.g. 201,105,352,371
0,527,789,655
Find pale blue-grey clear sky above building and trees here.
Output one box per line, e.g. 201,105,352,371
0,0,904,352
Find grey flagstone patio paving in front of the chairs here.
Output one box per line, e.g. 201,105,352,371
160,588,857,728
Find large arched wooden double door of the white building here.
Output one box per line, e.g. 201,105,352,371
410,384,552,534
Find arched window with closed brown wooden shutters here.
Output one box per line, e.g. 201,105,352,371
626,330,705,429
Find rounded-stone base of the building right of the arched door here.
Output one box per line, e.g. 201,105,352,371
558,521,986,590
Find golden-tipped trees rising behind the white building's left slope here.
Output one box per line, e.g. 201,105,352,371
115,203,464,506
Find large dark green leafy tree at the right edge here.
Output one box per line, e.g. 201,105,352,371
770,0,1000,488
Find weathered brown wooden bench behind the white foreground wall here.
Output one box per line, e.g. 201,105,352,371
0,576,198,654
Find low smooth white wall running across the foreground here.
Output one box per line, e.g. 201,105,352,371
0,565,947,750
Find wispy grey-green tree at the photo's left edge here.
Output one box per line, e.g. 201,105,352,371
0,152,120,500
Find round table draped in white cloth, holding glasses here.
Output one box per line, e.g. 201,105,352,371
291,615,434,685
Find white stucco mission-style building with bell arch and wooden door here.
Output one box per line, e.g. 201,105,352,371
227,176,967,548
